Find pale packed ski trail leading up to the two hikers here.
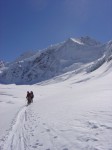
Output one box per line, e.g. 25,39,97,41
3,107,27,150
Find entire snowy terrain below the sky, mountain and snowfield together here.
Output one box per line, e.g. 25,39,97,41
0,38,112,150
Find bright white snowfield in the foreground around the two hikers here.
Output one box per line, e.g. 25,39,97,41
0,59,112,150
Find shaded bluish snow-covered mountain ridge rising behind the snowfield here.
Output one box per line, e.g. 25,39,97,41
0,36,112,84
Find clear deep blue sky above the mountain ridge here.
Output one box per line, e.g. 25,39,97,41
0,0,112,61
